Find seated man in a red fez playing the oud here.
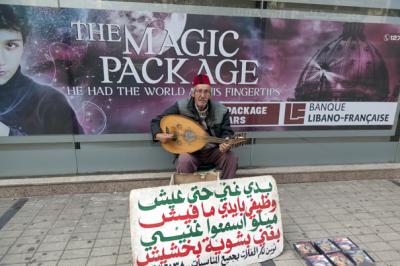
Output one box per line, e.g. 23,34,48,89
151,74,238,179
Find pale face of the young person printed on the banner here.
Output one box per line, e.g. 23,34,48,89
0,29,24,85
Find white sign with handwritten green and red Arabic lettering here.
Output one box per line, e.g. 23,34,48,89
130,176,284,266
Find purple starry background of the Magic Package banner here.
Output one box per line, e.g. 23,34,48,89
7,7,400,134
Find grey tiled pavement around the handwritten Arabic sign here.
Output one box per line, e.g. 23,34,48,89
0,180,400,266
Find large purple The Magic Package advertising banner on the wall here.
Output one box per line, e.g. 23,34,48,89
0,5,400,136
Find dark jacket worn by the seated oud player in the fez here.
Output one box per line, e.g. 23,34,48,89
151,97,234,140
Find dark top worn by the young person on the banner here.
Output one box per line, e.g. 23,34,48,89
0,69,83,135
